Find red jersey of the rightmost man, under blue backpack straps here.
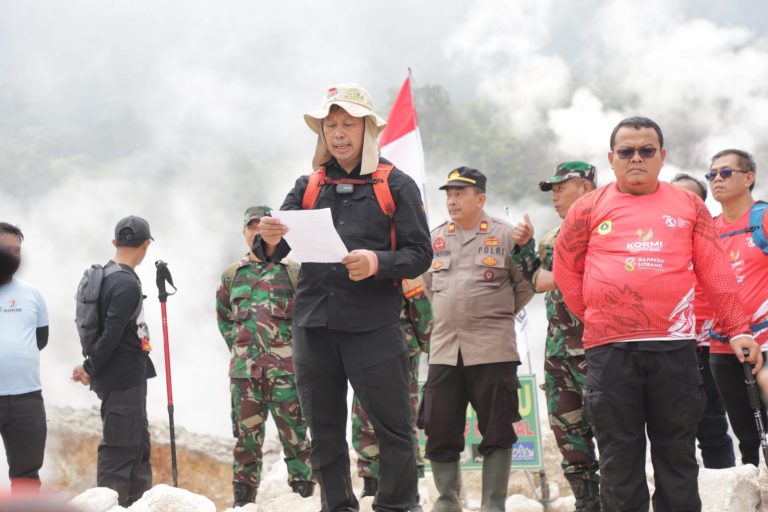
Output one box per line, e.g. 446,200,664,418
710,202,768,354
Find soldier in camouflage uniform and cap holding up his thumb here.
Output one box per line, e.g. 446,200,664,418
513,161,600,512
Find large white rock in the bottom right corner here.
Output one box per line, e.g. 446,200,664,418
699,464,760,512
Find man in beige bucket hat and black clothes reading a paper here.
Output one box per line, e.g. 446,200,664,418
255,84,432,512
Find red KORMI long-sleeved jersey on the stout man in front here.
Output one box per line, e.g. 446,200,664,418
554,183,749,350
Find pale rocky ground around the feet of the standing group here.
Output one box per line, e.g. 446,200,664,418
16,408,768,512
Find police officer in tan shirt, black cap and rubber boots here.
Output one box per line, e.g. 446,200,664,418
420,167,533,512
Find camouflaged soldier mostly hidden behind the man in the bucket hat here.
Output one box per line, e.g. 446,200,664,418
352,278,432,504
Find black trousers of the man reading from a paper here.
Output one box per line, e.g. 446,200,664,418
293,323,417,512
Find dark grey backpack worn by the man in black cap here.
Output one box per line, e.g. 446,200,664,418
75,263,128,357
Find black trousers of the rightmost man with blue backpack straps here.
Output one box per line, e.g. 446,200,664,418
709,352,768,466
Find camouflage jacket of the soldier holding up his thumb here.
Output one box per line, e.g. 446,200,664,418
512,227,584,357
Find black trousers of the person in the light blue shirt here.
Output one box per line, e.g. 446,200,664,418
0,391,48,486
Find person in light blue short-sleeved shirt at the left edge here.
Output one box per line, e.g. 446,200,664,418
0,222,48,493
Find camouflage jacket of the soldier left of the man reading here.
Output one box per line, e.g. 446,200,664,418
216,256,294,379
